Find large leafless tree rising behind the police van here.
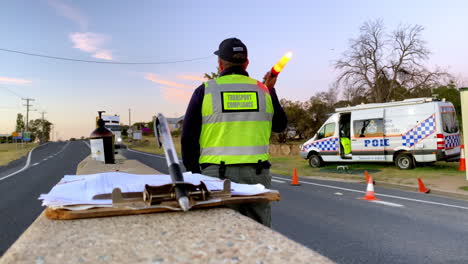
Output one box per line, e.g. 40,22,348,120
335,20,447,102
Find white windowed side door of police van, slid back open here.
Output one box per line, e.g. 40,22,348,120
351,108,389,161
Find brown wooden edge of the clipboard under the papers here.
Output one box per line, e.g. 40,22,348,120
45,191,280,220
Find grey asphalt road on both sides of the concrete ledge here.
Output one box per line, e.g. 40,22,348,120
0,144,468,263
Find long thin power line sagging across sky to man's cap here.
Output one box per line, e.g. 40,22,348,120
0,48,214,65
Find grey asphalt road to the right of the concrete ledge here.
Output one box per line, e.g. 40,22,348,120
123,150,468,264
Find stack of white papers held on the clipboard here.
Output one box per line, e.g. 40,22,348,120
39,172,270,208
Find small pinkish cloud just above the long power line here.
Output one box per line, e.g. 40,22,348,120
69,32,112,60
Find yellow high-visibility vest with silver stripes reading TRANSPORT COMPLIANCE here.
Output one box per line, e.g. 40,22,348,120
199,75,273,164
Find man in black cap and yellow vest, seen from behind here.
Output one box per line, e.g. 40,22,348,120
181,38,287,226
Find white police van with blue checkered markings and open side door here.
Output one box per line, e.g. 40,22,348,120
300,98,460,169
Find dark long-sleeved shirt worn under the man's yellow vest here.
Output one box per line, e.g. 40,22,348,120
181,67,288,173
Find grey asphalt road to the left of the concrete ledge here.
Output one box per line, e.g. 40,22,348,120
0,141,89,256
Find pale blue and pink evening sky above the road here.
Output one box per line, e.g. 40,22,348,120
0,0,468,140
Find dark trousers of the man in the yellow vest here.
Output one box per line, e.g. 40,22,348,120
202,165,271,227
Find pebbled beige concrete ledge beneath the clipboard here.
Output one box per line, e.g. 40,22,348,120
0,156,331,263
